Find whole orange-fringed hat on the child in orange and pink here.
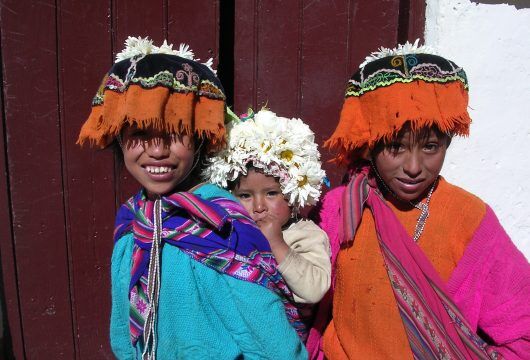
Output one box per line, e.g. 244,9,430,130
324,40,471,164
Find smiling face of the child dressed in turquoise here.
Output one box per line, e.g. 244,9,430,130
122,126,195,199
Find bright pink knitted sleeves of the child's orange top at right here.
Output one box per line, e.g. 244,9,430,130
307,179,530,359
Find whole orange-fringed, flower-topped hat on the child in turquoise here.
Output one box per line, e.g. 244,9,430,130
78,37,225,150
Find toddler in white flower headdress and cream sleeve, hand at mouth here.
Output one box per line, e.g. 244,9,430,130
205,110,331,304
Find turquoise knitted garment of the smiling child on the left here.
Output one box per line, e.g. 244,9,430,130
111,185,307,359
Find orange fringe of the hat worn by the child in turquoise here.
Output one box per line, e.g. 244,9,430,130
77,85,225,151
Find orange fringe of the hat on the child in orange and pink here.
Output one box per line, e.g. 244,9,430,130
324,81,471,164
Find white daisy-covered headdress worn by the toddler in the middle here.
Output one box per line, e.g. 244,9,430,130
204,109,326,210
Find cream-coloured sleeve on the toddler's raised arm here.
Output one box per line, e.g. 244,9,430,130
278,220,331,304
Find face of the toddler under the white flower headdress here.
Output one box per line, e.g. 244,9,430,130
234,169,291,228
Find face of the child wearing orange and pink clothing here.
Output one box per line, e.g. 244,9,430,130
374,129,449,201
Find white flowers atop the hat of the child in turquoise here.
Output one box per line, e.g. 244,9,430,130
115,36,215,73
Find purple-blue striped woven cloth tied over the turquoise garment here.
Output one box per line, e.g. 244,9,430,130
114,190,307,345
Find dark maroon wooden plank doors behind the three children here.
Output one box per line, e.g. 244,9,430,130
0,0,425,359
